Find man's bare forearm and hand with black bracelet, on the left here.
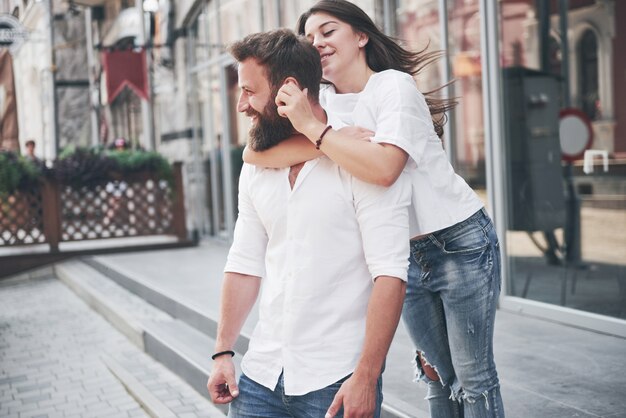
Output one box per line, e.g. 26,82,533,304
207,273,261,404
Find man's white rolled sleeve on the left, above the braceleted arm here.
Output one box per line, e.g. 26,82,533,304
224,164,268,277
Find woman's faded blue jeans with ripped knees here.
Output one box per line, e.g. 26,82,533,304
402,209,504,418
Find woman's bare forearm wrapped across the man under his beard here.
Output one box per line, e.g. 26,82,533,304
243,135,324,168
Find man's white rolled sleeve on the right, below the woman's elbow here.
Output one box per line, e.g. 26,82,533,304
353,173,411,281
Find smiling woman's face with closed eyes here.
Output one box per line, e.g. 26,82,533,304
304,13,368,85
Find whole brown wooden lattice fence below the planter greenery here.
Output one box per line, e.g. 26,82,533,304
0,163,187,252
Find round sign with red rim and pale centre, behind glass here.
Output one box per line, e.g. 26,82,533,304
559,108,593,161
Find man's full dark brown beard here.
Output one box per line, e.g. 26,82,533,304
246,96,294,151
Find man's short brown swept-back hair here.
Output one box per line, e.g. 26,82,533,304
228,29,322,102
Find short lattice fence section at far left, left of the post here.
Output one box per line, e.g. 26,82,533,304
0,187,47,246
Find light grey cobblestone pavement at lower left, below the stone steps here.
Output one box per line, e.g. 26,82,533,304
0,277,224,418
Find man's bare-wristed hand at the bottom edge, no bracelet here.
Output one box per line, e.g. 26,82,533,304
324,374,377,418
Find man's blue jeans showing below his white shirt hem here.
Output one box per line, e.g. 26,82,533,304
228,373,383,418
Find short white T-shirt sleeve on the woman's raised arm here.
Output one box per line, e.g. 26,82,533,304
371,71,436,164
